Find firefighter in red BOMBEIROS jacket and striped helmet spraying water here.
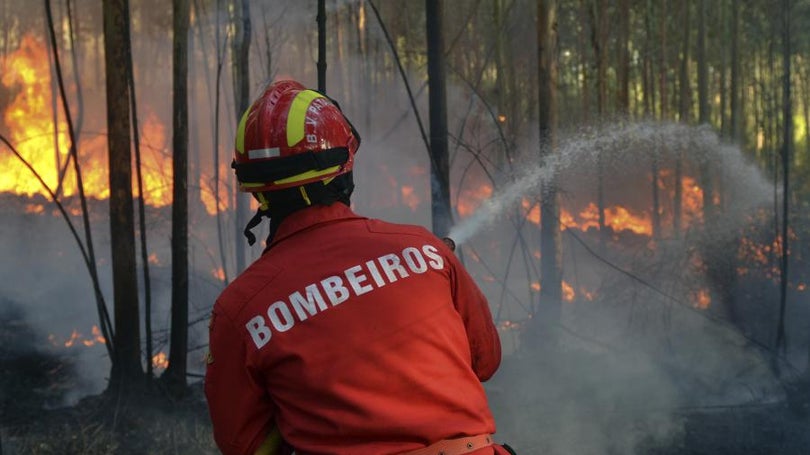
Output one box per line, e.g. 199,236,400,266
205,81,509,455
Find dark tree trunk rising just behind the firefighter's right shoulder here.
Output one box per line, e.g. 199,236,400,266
425,0,453,237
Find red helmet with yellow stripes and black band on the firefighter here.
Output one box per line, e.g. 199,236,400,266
231,80,360,193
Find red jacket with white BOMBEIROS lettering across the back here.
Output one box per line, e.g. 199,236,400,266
205,203,501,455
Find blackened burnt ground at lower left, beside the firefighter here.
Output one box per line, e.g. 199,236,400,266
0,302,219,455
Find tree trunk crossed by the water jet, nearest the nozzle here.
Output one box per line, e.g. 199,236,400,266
533,0,562,343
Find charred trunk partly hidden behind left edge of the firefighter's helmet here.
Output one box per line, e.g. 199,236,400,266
231,0,250,274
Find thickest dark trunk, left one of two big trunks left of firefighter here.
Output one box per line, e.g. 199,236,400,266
103,0,143,392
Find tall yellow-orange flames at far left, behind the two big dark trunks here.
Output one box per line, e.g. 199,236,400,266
0,34,172,206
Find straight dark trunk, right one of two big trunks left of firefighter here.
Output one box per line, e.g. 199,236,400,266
164,0,189,396
